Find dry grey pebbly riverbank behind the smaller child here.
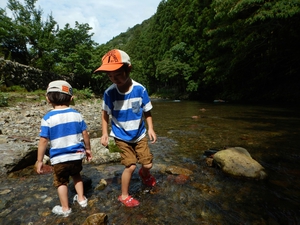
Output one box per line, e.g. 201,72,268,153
0,99,120,176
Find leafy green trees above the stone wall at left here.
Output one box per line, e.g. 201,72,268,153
0,0,97,88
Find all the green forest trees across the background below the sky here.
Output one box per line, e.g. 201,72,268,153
0,0,300,102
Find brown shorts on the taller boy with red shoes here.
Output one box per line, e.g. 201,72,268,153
115,137,153,166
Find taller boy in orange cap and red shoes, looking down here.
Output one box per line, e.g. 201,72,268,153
95,49,156,207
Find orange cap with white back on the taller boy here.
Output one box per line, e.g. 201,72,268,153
94,49,131,73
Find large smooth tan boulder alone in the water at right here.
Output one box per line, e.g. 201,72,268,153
213,147,267,179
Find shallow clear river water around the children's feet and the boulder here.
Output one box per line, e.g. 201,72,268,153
0,100,300,225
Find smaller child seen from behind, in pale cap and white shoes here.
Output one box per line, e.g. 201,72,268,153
37,80,92,217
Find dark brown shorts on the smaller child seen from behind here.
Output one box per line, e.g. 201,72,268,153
53,160,82,187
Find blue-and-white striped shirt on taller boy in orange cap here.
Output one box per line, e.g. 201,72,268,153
102,80,152,143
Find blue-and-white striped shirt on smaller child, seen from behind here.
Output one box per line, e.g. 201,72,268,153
40,108,87,165
